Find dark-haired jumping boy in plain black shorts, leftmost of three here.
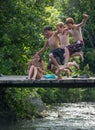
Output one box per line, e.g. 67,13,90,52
37,26,78,77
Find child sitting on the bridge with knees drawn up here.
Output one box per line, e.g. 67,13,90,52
28,54,45,80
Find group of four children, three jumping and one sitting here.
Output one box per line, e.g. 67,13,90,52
28,14,88,80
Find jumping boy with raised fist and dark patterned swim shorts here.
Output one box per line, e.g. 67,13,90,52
66,14,88,61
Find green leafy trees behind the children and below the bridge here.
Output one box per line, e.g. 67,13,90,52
0,0,95,120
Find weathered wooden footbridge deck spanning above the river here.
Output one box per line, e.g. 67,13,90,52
0,75,95,88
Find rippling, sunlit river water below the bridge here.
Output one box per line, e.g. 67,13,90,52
0,102,95,130
